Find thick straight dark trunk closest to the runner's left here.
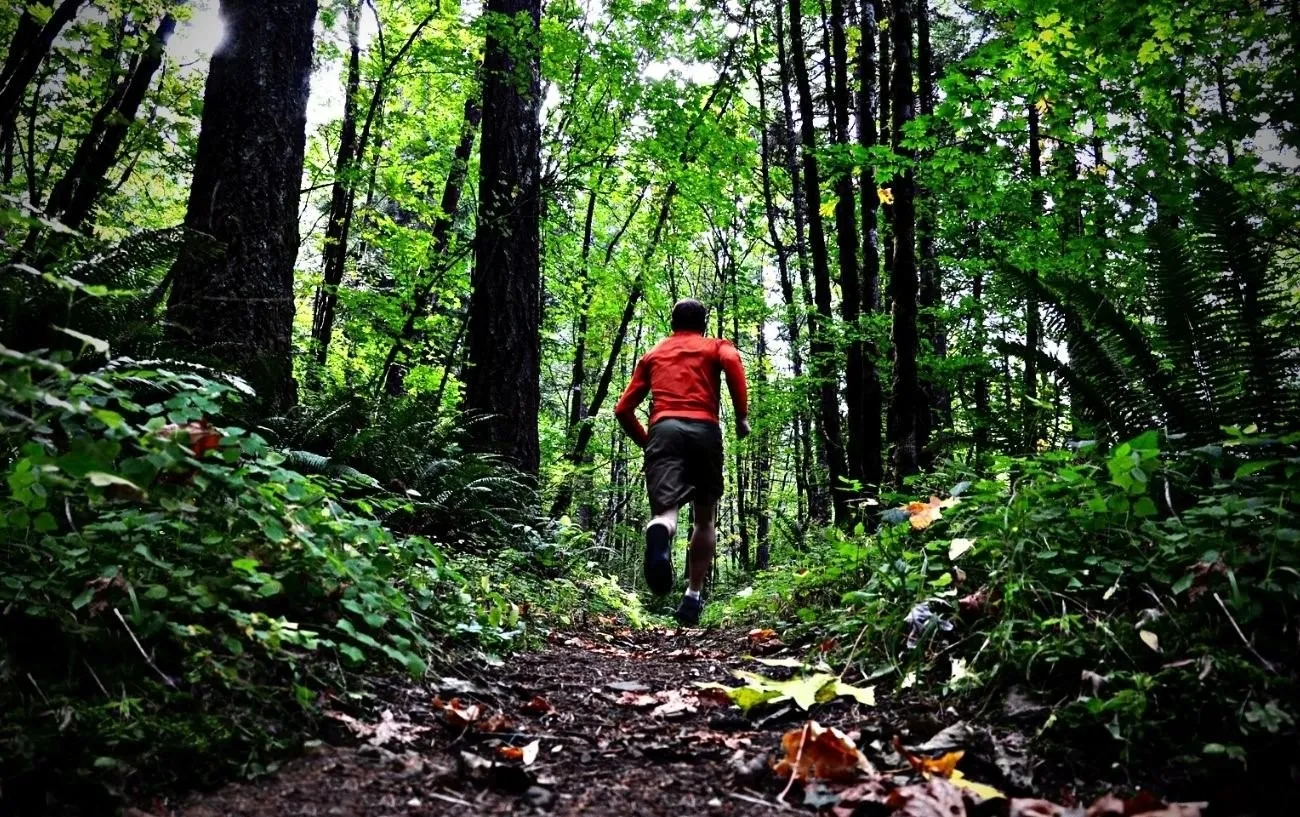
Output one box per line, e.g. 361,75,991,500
465,0,542,476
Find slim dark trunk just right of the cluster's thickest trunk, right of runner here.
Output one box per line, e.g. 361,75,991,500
915,0,953,467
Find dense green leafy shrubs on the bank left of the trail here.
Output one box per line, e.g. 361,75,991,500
0,347,512,794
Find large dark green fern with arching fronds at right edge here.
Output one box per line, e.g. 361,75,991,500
1001,173,1300,440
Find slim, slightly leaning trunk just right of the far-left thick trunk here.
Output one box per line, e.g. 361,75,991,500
312,0,364,371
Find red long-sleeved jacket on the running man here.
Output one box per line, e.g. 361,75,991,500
614,332,749,448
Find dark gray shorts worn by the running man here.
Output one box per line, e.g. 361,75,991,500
646,418,723,514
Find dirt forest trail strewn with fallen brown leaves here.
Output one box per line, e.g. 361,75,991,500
165,628,1201,817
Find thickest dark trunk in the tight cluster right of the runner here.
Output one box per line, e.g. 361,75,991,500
889,0,930,487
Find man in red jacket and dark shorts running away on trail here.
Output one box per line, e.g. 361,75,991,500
614,298,749,627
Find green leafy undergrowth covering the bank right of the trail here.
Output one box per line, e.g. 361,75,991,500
709,428,1300,771
